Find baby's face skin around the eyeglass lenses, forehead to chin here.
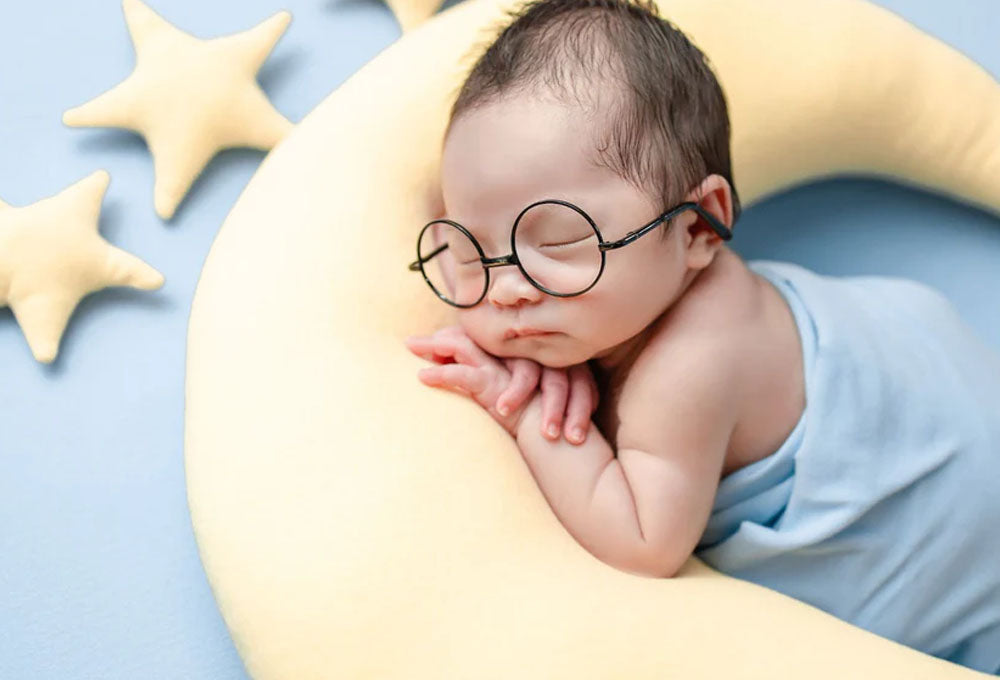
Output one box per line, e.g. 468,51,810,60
441,97,708,367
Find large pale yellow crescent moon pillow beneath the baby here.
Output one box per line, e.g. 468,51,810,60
185,0,1000,680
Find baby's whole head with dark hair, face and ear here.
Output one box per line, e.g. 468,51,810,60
421,0,740,367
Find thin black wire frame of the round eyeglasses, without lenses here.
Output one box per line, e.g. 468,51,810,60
407,198,733,309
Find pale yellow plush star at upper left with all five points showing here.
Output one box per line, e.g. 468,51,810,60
63,0,292,219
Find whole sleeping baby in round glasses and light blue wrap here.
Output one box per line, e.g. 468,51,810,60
406,0,1000,672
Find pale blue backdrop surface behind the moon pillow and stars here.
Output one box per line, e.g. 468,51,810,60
0,0,1000,680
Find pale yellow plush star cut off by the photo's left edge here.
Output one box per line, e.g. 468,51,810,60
0,170,163,363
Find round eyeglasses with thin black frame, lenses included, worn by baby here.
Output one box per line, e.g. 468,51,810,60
408,198,733,308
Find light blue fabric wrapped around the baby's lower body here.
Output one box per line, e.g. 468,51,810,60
695,260,1000,673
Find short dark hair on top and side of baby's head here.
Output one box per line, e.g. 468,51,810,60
445,0,740,238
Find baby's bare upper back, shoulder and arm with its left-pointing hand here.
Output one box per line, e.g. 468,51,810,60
411,242,805,577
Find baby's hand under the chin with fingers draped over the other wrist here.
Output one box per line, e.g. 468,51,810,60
497,358,599,444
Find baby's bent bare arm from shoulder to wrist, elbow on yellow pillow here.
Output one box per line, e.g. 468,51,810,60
517,342,736,577
